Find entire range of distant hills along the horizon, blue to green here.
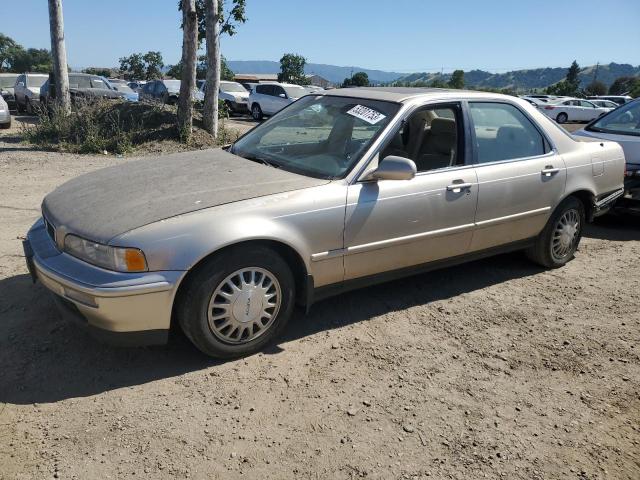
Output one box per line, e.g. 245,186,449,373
227,60,640,90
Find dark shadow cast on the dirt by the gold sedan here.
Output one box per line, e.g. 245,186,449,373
0,253,542,404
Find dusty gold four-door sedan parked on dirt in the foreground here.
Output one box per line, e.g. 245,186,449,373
24,88,625,358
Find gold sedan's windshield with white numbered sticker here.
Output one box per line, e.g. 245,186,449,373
230,96,400,179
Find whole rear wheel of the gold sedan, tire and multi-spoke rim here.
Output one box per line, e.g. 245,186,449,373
527,197,585,268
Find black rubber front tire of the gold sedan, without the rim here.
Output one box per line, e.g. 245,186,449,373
176,246,296,359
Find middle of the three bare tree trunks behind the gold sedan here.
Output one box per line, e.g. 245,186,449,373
178,0,198,141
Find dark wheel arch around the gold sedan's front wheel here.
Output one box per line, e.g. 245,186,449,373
171,238,313,328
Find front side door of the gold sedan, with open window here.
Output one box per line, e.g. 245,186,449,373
344,103,478,280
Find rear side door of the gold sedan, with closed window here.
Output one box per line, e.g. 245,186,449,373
468,101,567,251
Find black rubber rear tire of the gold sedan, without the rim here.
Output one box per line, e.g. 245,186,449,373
526,197,586,268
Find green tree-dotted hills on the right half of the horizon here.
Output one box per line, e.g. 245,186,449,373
395,63,640,90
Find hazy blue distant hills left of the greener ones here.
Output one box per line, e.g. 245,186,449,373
227,60,403,84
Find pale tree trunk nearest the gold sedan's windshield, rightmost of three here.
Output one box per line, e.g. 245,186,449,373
203,0,222,138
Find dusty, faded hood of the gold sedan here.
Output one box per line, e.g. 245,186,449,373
42,149,328,243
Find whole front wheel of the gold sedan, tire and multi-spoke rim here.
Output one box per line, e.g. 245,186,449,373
178,247,295,359
